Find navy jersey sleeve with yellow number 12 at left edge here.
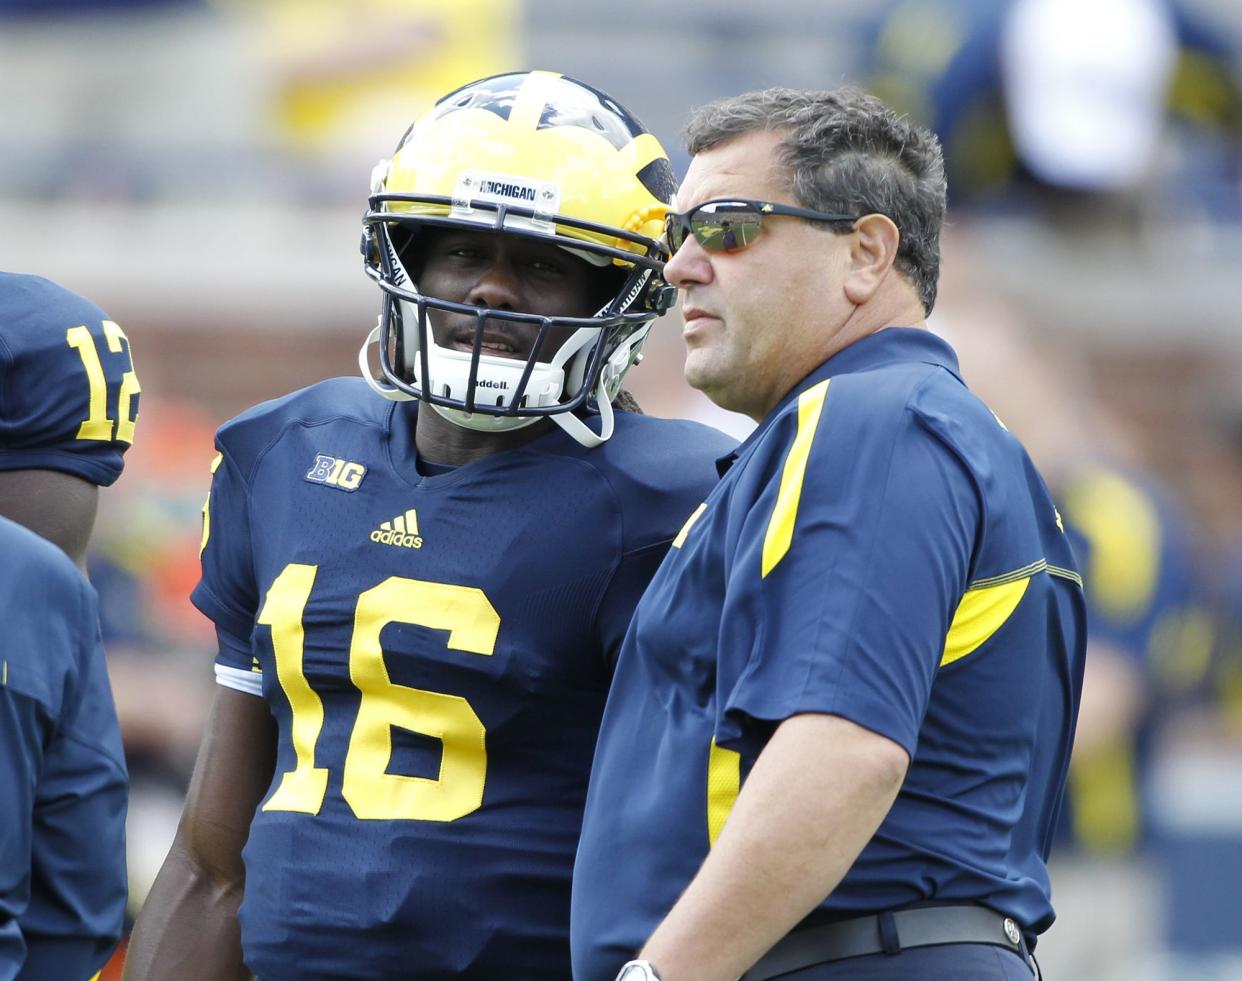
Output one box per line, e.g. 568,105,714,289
0,272,140,487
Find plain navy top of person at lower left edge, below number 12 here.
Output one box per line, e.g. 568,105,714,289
0,518,127,981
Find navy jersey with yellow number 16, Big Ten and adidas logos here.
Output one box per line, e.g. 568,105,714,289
194,379,733,981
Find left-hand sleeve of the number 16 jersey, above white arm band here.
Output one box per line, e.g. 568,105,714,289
190,437,258,672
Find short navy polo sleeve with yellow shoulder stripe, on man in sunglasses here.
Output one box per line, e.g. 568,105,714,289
717,379,980,756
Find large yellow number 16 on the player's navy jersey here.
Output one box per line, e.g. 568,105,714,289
258,563,501,821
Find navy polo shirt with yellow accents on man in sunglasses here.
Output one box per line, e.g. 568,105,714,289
573,328,1084,981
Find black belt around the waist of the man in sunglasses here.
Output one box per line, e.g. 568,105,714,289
740,906,1035,981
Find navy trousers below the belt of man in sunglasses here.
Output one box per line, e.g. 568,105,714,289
780,944,1035,981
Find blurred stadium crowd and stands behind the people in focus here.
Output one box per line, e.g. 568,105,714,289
0,0,1242,981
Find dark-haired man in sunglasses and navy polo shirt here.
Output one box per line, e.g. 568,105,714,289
571,88,1084,981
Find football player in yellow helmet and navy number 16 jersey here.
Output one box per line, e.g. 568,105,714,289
125,72,733,981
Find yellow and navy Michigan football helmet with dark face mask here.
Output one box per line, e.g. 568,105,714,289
360,72,676,445
